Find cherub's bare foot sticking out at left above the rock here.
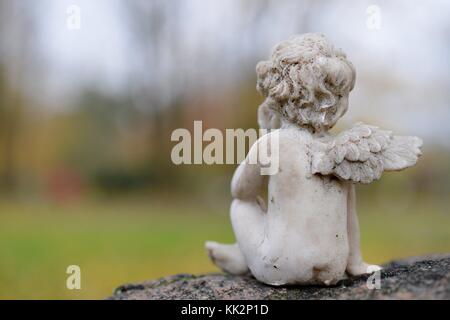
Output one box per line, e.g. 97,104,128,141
205,241,249,275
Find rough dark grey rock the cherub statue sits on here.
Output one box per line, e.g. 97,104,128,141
109,254,450,300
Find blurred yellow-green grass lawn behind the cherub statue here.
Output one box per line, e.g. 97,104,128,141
0,195,450,299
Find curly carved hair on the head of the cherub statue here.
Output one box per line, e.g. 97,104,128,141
256,33,355,130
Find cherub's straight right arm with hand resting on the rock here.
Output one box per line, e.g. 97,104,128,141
347,184,381,275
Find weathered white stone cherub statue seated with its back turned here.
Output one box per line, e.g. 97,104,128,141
206,33,422,285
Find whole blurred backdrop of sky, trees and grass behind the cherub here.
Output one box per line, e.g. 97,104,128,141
0,0,450,299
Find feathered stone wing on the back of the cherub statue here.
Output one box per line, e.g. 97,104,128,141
311,123,422,183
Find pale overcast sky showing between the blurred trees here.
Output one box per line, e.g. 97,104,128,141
33,0,450,145
